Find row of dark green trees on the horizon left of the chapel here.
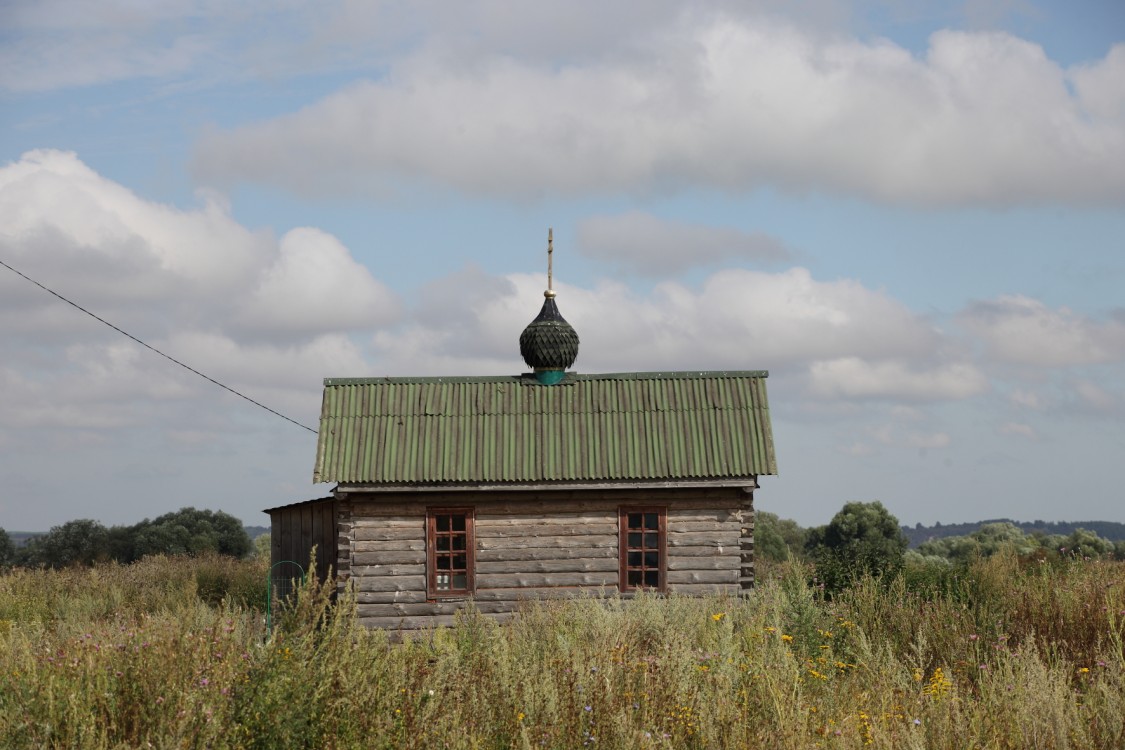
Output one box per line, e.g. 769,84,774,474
0,507,254,568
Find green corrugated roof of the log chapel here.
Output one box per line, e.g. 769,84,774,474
313,371,777,485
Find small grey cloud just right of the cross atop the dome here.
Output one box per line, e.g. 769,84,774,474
576,211,793,278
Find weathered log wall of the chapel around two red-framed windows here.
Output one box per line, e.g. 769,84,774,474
340,488,753,630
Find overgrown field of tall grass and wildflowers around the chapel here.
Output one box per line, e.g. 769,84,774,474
0,557,1125,749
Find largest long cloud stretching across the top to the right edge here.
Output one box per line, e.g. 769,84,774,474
196,13,1125,205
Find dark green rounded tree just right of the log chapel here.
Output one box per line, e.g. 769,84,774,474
806,500,908,591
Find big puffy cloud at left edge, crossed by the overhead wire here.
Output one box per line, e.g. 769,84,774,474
0,151,382,440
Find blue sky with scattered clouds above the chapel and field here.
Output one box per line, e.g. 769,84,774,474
0,0,1125,531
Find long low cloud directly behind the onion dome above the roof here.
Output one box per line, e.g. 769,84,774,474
376,263,988,404
